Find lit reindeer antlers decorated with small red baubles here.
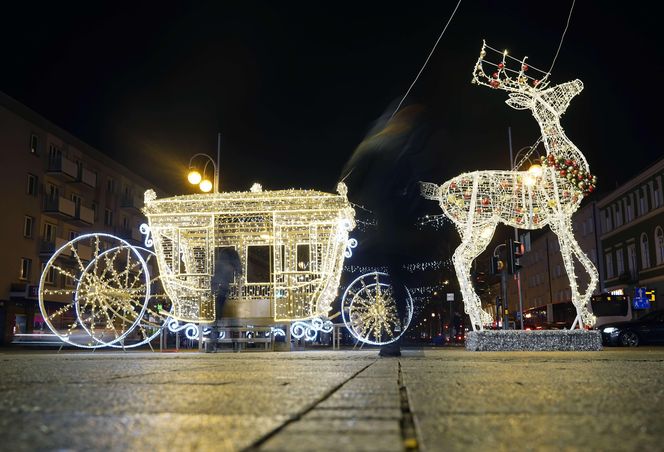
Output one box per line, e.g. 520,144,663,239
472,41,549,93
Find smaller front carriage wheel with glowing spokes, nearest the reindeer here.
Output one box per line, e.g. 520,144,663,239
341,272,413,345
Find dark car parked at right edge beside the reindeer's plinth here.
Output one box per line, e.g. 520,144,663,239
598,310,664,347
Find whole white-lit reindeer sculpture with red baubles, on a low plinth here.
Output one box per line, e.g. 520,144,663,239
422,43,599,330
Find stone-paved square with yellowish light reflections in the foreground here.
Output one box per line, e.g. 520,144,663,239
0,348,664,451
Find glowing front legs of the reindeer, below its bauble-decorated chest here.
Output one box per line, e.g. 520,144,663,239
551,215,599,327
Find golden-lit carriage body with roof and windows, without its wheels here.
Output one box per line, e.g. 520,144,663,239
143,184,355,325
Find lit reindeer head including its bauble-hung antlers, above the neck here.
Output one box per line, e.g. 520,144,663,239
473,42,583,116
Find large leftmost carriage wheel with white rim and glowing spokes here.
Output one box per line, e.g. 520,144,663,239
39,234,151,348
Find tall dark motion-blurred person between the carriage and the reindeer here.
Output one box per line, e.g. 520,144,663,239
341,101,430,356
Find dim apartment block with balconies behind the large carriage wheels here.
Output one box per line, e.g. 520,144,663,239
0,93,165,344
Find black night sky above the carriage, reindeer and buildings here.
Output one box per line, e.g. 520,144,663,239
0,0,664,270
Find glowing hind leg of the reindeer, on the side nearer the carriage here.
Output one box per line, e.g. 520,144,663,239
452,224,496,331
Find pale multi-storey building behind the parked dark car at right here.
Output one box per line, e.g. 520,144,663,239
598,159,664,315
